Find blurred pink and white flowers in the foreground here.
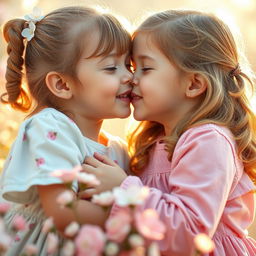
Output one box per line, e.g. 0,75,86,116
0,167,214,256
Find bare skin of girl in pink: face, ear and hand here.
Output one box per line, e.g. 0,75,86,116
80,33,207,198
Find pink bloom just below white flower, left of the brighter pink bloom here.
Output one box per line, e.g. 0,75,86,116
105,211,132,243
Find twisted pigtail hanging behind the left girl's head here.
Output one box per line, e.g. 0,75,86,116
1,19,31,112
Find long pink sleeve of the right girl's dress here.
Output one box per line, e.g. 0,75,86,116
111,126,239,256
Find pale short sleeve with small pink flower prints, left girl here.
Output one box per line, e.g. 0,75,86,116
2,111,85,203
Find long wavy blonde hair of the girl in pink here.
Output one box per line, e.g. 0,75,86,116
129,10,256,182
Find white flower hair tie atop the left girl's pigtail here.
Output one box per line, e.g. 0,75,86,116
21,7,44,41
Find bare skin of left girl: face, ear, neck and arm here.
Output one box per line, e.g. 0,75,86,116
37,32,132,233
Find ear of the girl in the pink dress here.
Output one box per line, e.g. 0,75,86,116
185,73,208,98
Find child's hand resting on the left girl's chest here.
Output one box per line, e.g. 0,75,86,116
78,153,127,199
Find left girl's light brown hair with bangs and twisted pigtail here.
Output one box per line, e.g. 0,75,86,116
1,7,131,115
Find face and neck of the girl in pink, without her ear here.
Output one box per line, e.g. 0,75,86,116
132,34,199,135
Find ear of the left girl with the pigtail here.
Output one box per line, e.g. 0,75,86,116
45,71,73,99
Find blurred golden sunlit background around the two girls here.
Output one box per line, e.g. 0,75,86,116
0,0,256,238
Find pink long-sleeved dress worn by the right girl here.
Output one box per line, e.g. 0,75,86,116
111,124,256,256
